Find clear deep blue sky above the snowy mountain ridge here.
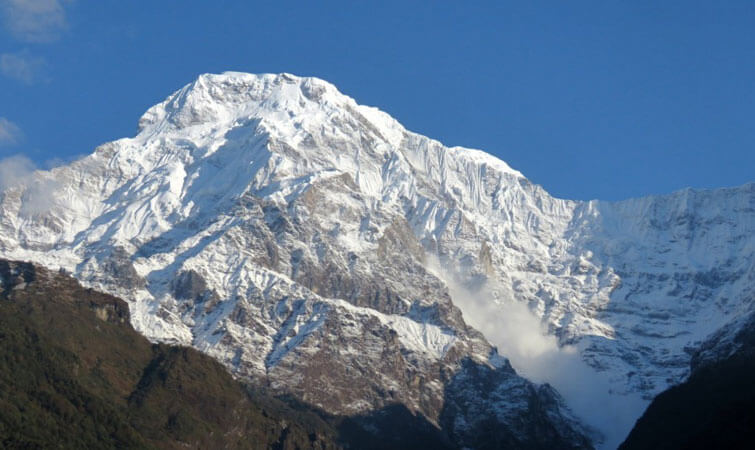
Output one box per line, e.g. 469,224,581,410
0,0,755,200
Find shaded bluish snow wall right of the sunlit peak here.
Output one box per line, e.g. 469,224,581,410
569,184,755,394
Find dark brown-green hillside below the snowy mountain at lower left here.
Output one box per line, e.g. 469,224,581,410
0,260,340,449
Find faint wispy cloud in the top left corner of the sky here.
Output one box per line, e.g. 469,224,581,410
0,0,68,43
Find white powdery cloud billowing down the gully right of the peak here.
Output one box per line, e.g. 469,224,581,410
428,257,648,449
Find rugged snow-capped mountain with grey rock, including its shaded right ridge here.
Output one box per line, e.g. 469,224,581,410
0,73,755,447
